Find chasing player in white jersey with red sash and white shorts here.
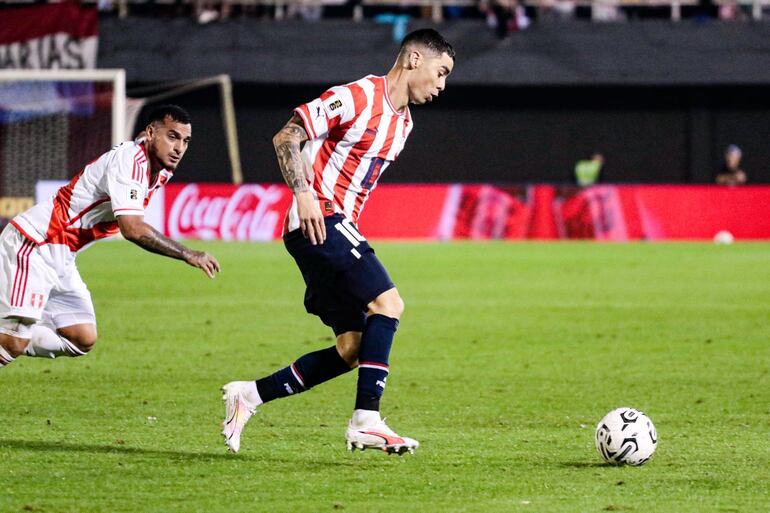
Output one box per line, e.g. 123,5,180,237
0,105,219,367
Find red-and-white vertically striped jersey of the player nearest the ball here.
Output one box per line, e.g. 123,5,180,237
285,75,413,231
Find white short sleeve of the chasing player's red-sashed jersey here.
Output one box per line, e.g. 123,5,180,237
107,146,147,216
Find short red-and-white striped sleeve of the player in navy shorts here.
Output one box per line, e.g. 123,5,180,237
294,86,362,139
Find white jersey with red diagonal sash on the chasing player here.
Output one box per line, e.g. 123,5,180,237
11,141,173,252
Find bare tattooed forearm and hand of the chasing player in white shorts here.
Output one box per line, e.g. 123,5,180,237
118,216,220,278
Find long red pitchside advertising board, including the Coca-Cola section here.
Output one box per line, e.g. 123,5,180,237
164,184,770,241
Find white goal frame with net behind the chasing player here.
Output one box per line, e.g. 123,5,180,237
0,69,243,202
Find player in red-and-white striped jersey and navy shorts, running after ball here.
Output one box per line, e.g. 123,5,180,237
223,29,455,454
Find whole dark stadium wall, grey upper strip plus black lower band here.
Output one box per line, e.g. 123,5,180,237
112,19,770,183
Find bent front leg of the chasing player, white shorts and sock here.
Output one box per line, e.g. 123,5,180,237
26,262,97,358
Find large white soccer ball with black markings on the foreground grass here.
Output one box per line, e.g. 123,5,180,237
596,408,658,465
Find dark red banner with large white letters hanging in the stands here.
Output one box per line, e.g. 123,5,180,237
0,2,98,69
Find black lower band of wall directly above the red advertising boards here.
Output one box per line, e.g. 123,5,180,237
138,84,770,183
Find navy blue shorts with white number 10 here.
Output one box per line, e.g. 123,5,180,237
283,214,394,335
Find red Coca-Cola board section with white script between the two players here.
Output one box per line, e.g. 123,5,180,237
165,183,291,241
